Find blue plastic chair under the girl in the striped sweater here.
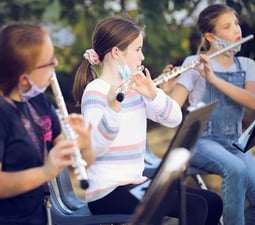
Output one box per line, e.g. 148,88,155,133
50,168,131,225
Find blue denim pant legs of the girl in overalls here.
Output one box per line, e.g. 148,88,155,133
190,138,255,225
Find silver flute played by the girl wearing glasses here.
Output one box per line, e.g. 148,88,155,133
50,73,89,189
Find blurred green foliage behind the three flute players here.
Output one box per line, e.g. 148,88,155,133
0,0,255,106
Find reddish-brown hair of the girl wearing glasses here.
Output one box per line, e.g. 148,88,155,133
0,23,48,96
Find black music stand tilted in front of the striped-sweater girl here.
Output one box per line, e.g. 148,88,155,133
130,102,217,225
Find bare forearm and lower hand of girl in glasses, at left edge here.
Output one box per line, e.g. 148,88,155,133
0,141,74,198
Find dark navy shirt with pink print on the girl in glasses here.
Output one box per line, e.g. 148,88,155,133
0,94,61,225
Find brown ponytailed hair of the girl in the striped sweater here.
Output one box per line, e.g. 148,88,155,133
73,16,143,105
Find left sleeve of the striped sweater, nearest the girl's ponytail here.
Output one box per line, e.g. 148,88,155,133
81,81,120,156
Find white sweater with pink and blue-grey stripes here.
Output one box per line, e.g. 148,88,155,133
81,79,182,201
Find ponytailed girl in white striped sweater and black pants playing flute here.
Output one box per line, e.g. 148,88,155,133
74,17,222,225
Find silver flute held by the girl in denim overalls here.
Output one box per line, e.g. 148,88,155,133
153,34,253,86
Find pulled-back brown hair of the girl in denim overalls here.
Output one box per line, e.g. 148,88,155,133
197,4,236,54
